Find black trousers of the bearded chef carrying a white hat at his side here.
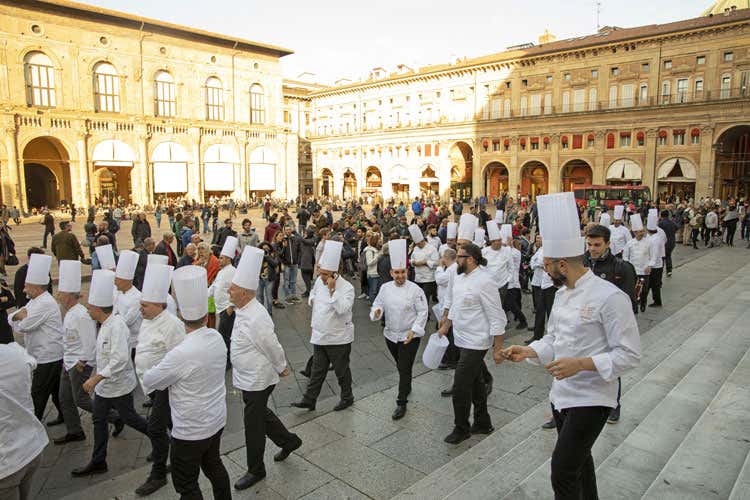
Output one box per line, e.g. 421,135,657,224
453,347,492,434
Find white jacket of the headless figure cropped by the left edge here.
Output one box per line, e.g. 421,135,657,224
0,342,49,478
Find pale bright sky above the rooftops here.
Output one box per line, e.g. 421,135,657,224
78,0,711,84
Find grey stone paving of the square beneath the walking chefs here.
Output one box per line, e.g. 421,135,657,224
2,209,748,499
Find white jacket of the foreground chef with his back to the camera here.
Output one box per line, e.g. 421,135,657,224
143,327,227,441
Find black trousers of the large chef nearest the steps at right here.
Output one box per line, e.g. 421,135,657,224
552,406,611,500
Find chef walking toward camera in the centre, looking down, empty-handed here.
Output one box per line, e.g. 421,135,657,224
370,239,429,420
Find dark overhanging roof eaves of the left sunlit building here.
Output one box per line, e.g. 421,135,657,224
8,0,294,57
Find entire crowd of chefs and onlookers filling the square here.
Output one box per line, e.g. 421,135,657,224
0,188,750,499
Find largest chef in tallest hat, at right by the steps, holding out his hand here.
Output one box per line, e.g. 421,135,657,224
502,192,641,498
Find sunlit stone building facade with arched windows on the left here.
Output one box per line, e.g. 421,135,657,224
0,0,299,210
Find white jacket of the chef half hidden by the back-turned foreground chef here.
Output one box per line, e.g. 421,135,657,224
135,309,185,394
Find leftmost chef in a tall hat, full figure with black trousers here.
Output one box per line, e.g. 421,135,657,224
10,254,67,426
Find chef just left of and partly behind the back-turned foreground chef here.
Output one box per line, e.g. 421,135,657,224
135,264,185,496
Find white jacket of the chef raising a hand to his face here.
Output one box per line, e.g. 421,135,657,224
308,276,354,345
